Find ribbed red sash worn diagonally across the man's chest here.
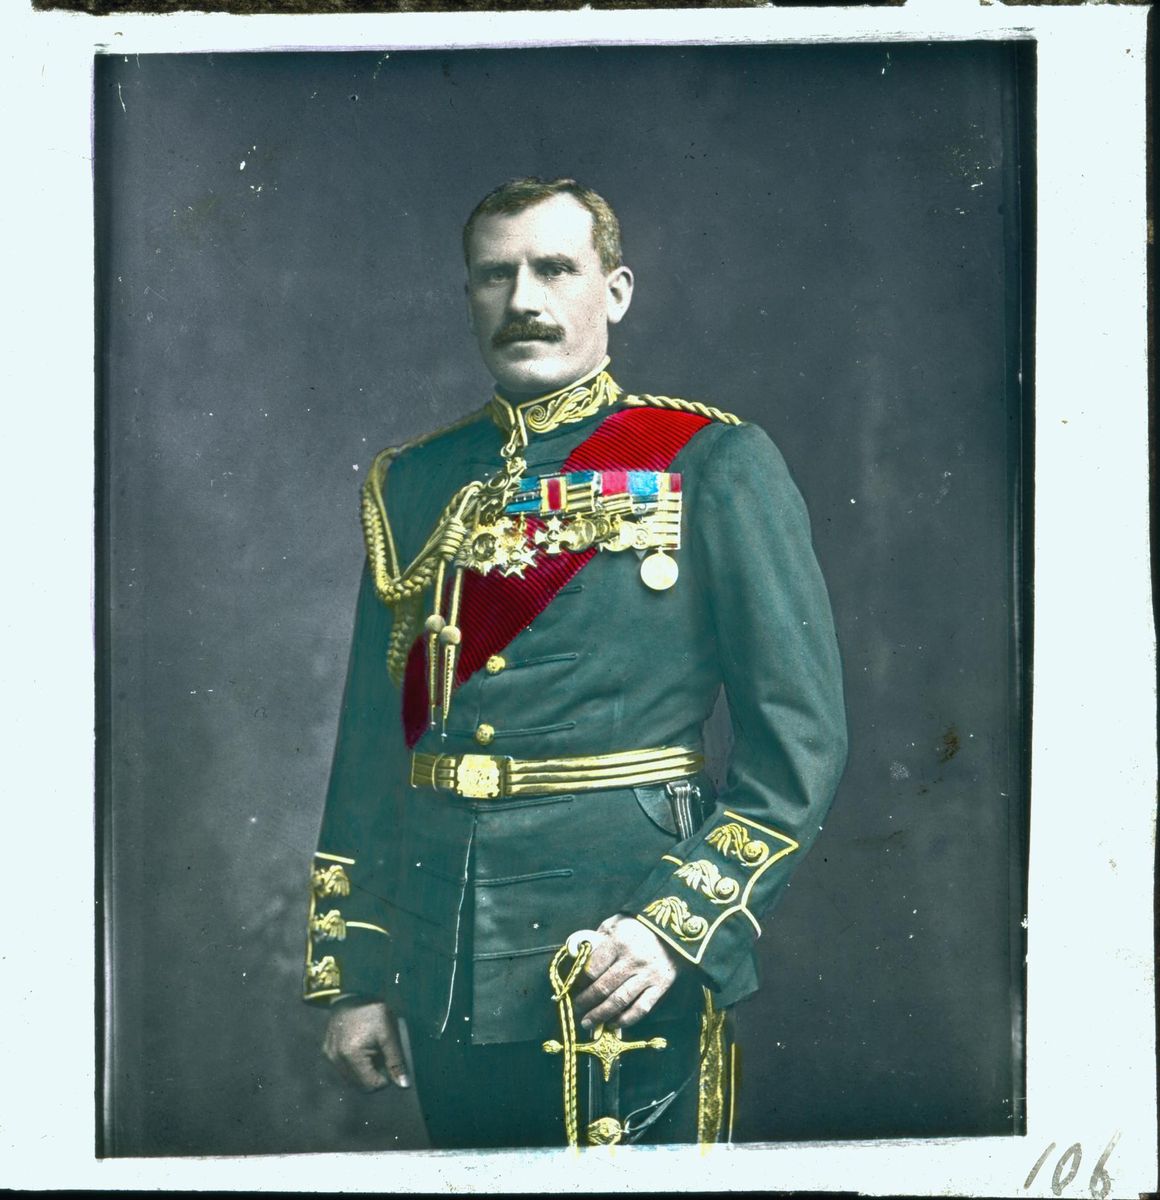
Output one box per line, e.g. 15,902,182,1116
403,408,711,746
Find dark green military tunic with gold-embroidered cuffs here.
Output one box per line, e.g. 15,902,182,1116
307,379,846,1042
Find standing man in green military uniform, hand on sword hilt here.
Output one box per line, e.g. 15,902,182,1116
306,180,846,1147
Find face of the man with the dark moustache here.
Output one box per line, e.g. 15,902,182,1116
467,196,632,396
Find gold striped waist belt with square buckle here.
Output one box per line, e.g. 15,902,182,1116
410,746,705,800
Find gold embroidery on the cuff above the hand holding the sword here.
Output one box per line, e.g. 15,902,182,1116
637,809,801,962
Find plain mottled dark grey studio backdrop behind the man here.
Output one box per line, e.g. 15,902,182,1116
95,43,1026,1154
